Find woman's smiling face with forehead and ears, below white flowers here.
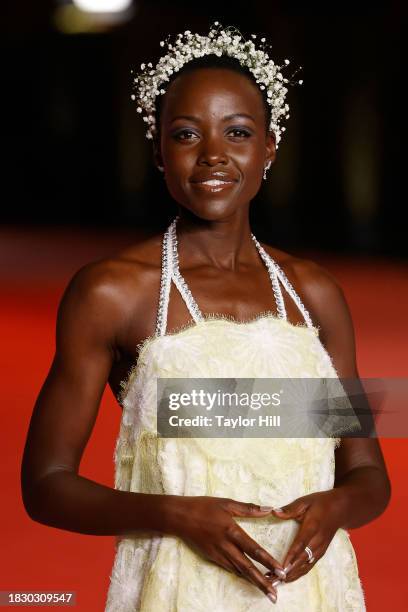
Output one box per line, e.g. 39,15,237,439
156,68,275,220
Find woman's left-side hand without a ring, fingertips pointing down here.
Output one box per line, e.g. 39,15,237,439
171,496,283,603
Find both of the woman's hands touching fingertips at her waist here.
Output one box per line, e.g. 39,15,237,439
171,488,345,603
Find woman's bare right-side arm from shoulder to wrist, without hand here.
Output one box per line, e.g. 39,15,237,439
303,262,391,529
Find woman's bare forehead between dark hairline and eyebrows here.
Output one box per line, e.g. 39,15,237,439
162,68,264,121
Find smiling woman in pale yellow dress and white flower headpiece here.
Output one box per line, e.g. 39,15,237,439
22,24,390,612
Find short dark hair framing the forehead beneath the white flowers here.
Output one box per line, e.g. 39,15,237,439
155,53,271,139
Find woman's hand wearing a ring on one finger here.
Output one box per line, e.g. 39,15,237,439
266,489,342,582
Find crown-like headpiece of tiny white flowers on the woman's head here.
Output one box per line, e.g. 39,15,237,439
131,21,303,145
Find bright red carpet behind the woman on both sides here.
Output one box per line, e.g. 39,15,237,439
0,229,408,612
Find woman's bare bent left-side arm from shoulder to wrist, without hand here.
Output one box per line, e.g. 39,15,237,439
21,264,177,535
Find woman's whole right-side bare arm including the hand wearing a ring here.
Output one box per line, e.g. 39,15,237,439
274,260,391,582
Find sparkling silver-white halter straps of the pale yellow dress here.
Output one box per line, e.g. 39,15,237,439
156,216,314,336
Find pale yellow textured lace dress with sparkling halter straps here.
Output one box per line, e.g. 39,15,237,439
105,219,365,612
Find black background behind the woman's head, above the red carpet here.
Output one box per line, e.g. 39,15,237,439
0,0,408,259
